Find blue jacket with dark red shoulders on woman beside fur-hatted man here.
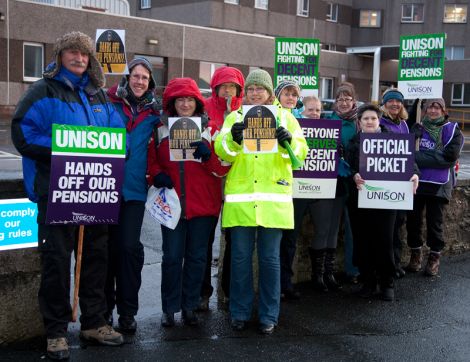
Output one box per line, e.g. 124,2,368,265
108,85,160,201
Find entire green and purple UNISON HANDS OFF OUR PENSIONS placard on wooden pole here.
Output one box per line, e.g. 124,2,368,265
46,124,126,225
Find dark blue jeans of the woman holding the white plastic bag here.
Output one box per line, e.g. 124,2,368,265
161,216,217,313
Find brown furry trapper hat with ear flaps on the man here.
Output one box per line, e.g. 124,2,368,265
44,31,105,88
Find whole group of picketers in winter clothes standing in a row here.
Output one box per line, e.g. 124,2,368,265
12,32,463,360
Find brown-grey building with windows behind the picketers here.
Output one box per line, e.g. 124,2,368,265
0,0,470,107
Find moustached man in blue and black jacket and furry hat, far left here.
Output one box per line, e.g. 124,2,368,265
11,32,124,360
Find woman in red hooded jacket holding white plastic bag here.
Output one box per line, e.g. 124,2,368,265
148,78,229,327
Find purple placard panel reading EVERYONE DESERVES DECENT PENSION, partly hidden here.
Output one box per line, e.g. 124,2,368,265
294,118,341,179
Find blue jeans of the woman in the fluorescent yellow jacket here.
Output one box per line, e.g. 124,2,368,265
230,226,282,324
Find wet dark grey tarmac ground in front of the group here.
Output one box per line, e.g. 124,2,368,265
0,226,470,361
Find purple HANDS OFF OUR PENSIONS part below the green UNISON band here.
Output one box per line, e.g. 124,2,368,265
46,154,125,225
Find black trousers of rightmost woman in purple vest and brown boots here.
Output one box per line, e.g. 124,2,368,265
406,195,448,252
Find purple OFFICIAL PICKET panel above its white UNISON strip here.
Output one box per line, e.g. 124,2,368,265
359,133,414,181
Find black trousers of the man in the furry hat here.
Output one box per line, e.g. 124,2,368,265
38,201,108,338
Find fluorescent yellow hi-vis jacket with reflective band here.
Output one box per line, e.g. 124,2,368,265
215,100,308,229
